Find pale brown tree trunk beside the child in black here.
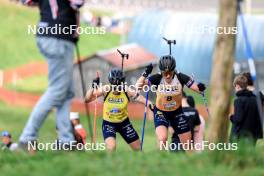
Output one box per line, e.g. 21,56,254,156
208,0,237,142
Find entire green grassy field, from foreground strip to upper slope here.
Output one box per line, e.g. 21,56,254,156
0,0,264,176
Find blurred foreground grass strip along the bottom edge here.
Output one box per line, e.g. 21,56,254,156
0,148,264,176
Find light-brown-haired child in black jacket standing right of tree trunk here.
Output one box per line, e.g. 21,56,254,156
230,75,263,145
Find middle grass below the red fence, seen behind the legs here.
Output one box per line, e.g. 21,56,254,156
0,101,156,151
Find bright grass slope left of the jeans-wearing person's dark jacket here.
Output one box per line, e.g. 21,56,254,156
0,0,41,69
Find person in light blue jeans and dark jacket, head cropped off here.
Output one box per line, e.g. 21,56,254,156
19,0,84,152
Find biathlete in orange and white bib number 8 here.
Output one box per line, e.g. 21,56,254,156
137,55,206,151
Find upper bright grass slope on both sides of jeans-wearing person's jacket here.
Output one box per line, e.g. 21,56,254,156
0,0,120,69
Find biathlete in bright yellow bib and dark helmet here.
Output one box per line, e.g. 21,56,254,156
86,68,154,151
